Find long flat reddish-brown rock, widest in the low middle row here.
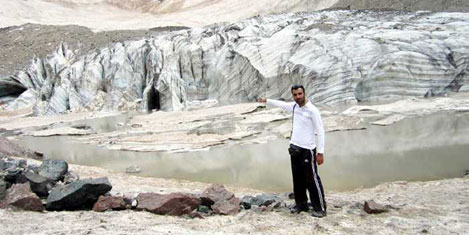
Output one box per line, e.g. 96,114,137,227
137,193,201,216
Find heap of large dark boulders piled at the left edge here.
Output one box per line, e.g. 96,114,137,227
0,156,112,211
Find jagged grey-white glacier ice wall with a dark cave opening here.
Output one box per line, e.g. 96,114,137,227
0,10,469,115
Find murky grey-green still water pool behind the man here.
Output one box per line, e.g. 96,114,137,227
13,113,469,192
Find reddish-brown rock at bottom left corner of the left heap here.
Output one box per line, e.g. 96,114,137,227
3,183,44,211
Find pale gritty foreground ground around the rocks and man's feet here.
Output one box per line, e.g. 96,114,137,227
0,156,469,234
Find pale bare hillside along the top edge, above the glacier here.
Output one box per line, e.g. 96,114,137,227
0,0,469,31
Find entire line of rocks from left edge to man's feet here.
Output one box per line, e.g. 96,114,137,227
0,156,285,218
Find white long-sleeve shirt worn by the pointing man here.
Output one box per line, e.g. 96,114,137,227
267,99,325,153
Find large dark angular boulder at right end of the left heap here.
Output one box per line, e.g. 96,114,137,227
46,178,112,211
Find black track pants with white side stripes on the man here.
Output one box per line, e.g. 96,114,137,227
288,144,326,211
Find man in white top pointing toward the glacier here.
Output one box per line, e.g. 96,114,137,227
259,85,326,217
